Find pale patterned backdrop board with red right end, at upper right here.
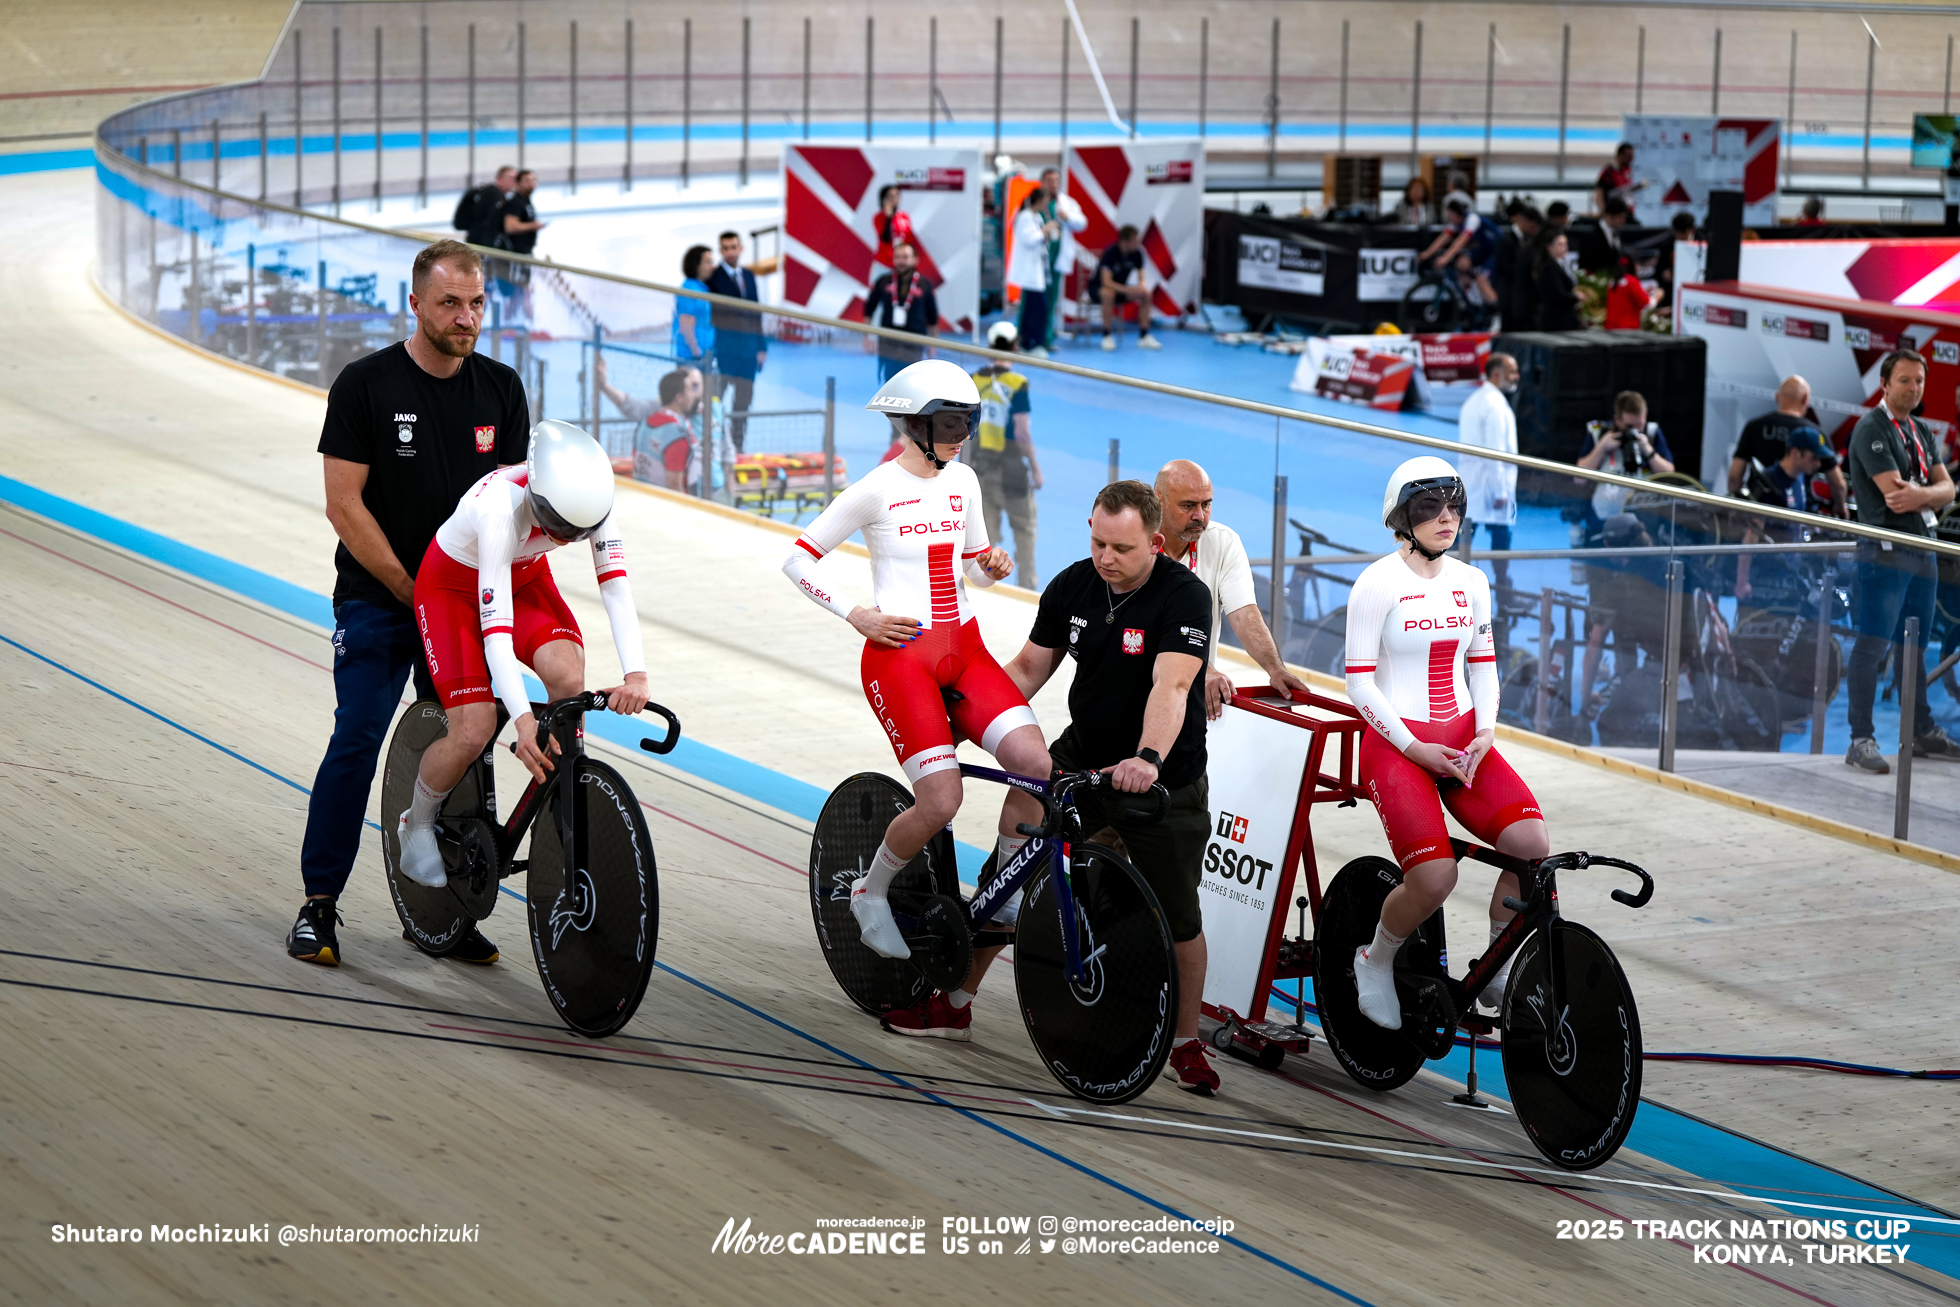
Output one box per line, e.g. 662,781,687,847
1621,114,1784,227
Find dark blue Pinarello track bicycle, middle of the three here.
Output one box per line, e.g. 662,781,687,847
809,762,1178,1103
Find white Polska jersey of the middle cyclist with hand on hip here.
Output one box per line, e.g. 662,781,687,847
782,459,994,627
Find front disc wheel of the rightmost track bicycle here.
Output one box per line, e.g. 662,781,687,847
1503,921,1642,1172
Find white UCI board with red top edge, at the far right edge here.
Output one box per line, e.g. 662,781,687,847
1680,282,1960,486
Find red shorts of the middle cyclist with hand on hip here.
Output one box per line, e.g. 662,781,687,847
860,617,1035,784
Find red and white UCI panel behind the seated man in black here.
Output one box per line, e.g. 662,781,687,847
1064,139,1205,315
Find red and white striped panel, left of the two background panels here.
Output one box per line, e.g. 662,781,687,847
782,143,980,335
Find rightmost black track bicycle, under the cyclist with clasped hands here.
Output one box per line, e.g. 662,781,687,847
1313,839,1654,1172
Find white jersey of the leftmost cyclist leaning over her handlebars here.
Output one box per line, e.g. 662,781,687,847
435,466,647,721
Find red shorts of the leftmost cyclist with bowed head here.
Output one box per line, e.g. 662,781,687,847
416,541,586,707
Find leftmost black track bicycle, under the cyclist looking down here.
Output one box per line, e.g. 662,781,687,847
380,690,680,1039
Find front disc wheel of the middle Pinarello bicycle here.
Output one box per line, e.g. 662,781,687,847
1013,845,1178,1103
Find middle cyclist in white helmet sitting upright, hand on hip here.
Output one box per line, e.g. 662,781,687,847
782,368,1049,991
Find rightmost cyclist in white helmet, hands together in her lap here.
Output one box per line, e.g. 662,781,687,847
1347,457,1550,1031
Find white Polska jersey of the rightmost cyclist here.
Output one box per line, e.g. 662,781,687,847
1347,553,1497,750
